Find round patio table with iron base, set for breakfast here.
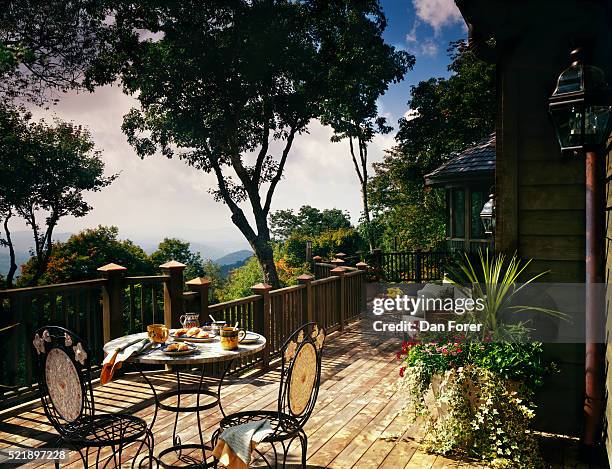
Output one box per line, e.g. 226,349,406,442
104,332,266,468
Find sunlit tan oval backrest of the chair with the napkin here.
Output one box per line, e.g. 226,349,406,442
278,322,325,428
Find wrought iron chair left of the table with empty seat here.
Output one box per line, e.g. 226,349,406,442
33,326,153,467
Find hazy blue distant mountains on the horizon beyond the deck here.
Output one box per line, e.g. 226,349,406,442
0,231,253,276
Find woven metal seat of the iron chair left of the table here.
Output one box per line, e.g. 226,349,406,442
67,414,147,446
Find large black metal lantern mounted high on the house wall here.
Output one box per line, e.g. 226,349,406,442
548,49,612,153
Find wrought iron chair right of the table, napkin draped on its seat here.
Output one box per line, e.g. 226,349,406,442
212,322,325,468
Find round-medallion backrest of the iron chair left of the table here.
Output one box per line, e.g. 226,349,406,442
32,326,94,438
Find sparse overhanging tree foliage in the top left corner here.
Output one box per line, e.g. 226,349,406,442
0,0,104,103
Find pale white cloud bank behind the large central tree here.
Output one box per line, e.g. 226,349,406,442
20,86,394,255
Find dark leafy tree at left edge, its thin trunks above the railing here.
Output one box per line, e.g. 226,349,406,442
0,106,116,287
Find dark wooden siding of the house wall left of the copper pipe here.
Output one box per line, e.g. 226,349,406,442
495,40,585,435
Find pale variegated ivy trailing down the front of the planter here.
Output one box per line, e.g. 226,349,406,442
404,365,543,469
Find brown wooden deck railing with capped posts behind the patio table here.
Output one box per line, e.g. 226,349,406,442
0,261,366,410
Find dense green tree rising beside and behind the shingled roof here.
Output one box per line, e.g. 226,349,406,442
368,41,496,249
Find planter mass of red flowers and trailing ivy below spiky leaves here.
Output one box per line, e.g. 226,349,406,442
398,337,550,468
